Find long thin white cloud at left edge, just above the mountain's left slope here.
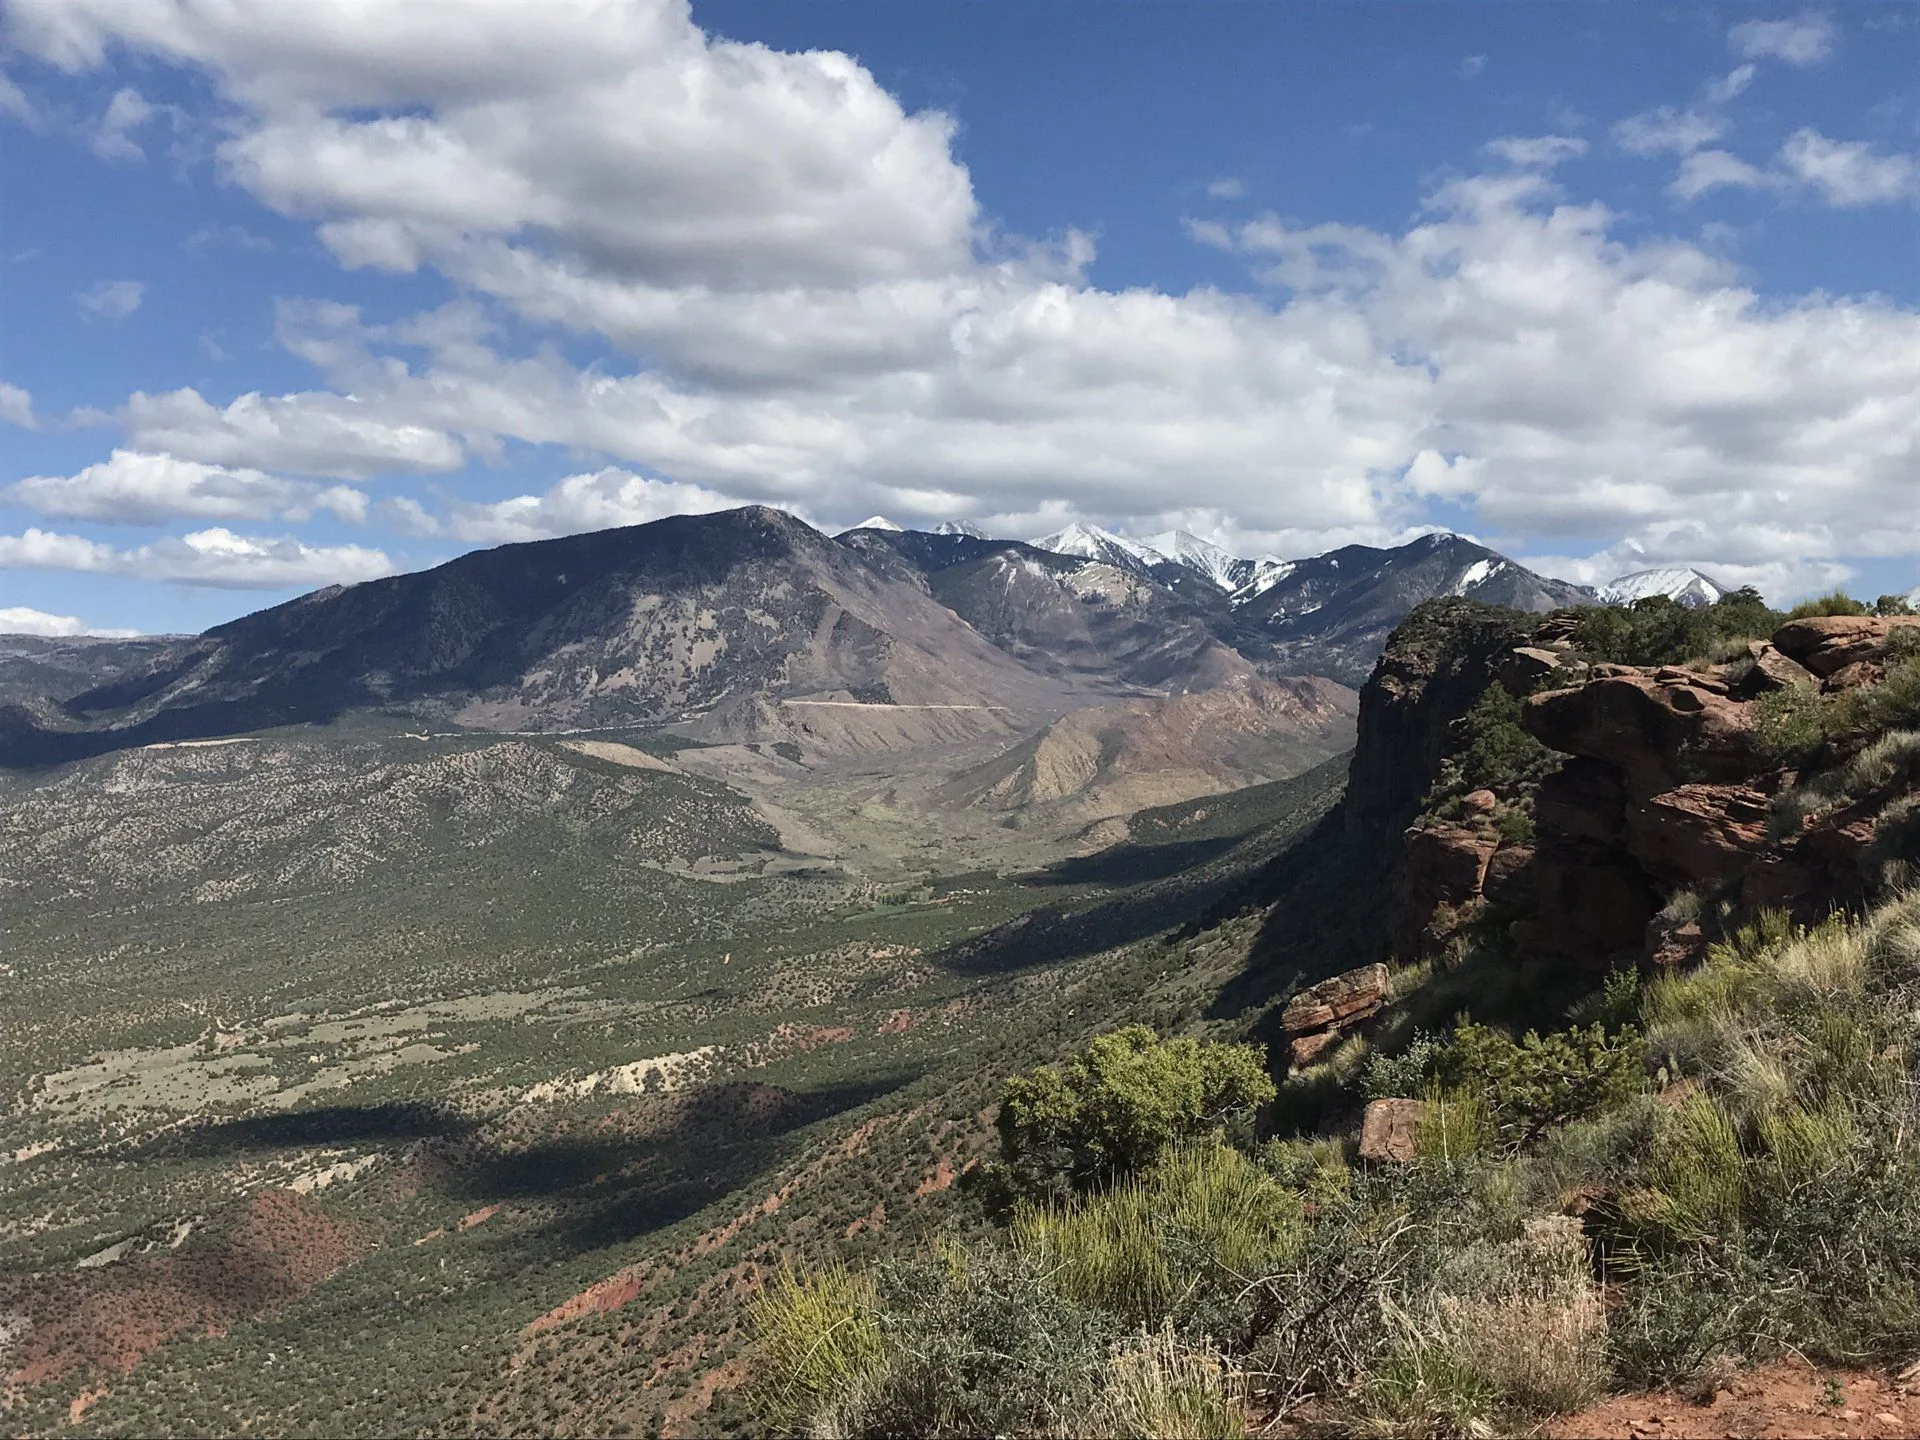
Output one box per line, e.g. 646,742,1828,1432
0,526,394,589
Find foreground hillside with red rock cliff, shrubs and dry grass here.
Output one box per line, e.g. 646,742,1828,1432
756,591,1920,1436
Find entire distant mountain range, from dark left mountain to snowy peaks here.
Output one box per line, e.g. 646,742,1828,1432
0,507,1620,764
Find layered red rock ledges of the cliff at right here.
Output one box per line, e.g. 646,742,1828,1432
1361,616,1920,970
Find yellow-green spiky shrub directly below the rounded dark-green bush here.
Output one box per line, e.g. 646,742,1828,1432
1014,1144,1302,1329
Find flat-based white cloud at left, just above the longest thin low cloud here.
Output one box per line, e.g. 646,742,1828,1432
0,449,367,524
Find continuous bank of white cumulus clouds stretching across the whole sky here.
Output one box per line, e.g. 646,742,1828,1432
10,0,1920,599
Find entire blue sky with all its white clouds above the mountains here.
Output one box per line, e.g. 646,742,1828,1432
0,0,1920,634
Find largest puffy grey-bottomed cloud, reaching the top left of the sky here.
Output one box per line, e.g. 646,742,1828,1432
10,0,975,288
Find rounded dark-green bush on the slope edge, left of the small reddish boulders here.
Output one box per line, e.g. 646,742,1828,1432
996,1025,1275,1198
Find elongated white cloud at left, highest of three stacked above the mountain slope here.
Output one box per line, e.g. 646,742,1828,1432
117,388,467,480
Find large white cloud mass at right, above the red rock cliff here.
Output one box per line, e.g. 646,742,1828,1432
1198,177,1920,599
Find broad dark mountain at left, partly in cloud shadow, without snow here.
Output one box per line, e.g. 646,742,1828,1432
0,507,1062,762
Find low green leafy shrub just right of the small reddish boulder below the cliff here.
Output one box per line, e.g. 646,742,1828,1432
1453,1021,1645,1144
